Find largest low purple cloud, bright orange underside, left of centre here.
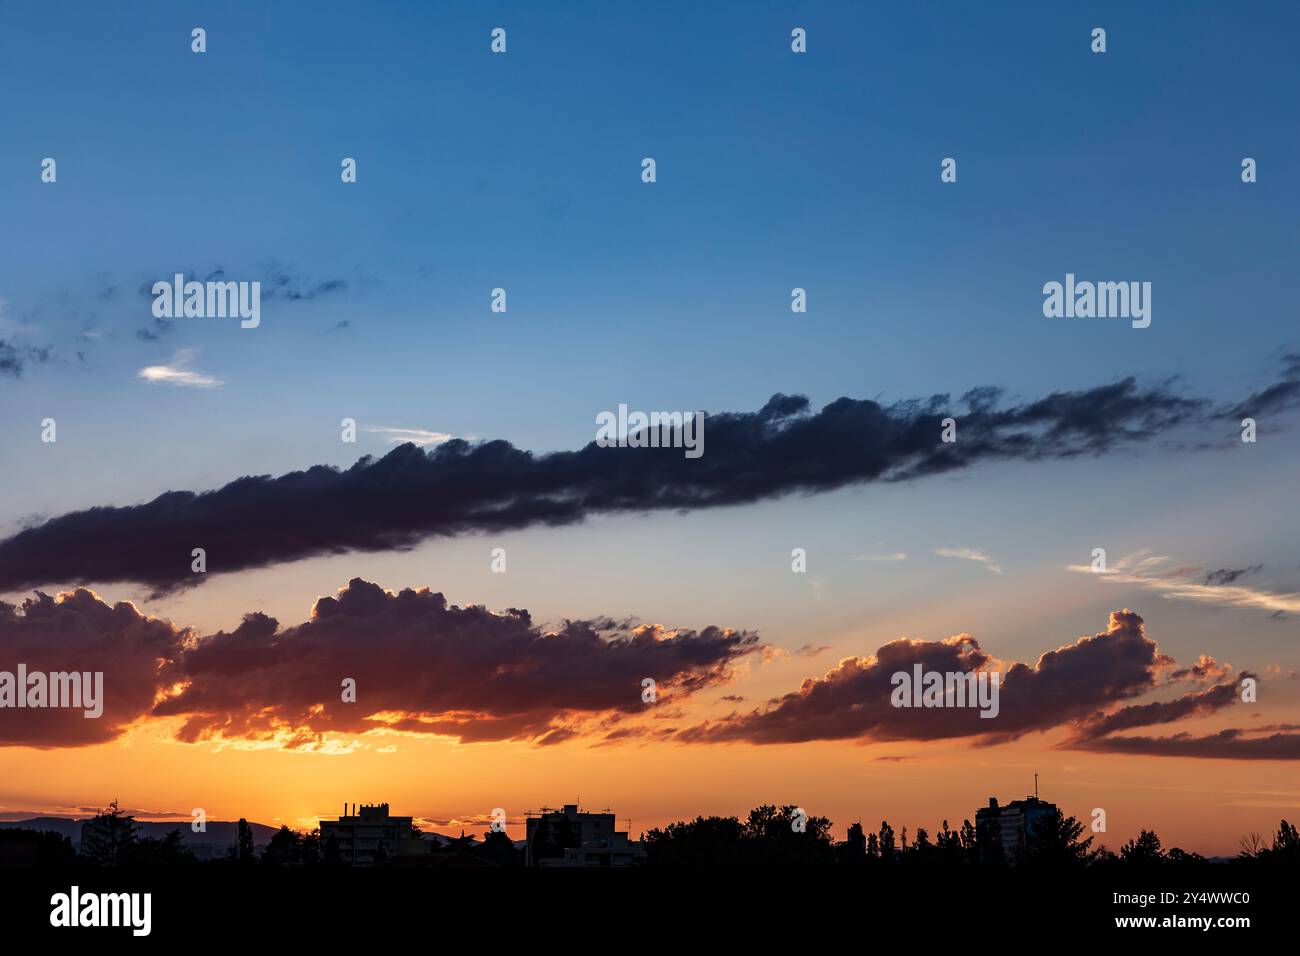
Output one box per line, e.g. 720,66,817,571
155,579,758,748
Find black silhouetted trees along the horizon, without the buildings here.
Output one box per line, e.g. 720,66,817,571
0,805,1300,870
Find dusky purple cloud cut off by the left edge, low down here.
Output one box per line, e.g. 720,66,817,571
0,589,189,747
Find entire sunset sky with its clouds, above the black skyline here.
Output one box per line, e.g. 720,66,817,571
0,0,1300,853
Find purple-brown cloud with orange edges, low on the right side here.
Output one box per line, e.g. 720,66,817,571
677,610,1300,760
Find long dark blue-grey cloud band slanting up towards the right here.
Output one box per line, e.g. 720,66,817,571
0,367,1253,592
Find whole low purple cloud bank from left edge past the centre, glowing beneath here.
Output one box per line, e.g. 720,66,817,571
0,579,761,749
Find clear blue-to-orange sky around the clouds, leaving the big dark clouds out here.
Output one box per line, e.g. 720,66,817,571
0,0,1300,852
